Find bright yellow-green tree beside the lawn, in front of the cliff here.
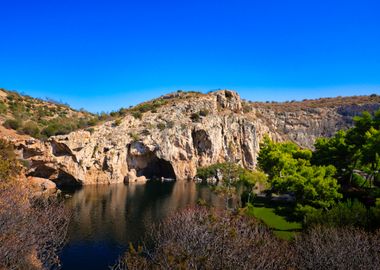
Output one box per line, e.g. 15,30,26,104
258,137,342,208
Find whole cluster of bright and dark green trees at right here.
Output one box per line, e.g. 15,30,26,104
258,111,380,226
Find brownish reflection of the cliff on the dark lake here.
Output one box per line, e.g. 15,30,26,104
62,181,223,246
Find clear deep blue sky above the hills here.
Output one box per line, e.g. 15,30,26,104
0,0,380,112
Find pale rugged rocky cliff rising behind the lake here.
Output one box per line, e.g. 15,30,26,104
10,90,380,185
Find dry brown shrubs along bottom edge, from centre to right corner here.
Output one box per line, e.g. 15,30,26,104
113,207,380,270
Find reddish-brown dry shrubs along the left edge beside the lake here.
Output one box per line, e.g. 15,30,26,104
0,140,70,269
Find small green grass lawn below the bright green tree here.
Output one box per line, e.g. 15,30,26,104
247,201,302,240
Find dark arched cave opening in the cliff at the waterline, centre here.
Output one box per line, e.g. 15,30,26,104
137,157,175,179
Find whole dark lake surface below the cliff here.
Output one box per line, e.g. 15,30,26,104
61,181,223,270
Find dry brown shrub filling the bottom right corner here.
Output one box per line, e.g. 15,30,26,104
294,226,380,270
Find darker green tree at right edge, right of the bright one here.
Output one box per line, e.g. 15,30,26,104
312,110,380,185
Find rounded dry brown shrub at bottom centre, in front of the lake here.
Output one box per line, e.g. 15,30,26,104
114,208,292,269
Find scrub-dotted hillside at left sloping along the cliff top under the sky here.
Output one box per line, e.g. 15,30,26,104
0,89,208,139
